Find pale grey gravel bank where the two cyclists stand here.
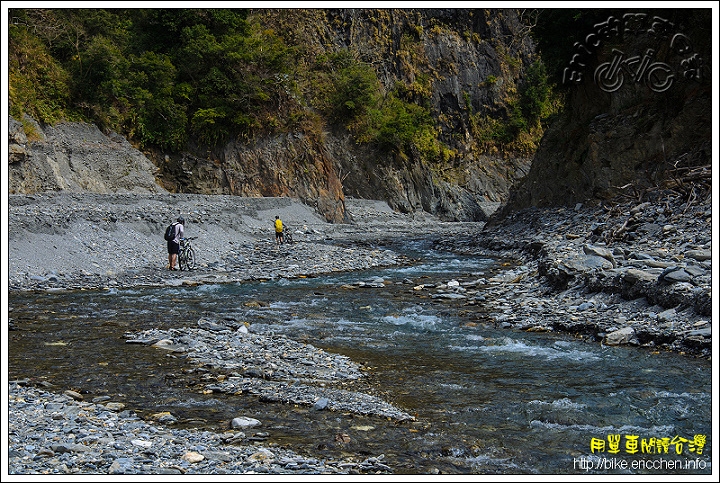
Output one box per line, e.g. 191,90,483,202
8,194,456,291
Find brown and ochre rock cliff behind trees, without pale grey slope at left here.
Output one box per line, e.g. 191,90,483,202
150,9,533,222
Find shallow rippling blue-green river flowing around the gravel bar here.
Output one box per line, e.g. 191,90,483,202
8,243,712,475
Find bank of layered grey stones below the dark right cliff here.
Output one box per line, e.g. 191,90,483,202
439,191,713,358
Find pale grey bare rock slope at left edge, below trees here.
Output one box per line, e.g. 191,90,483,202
8,117,166,194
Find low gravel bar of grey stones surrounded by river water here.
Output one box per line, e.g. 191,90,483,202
125,326,415,429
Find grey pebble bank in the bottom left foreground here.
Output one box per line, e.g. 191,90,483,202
7,381,392,475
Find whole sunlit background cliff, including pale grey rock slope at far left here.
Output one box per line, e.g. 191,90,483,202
10,9,533,222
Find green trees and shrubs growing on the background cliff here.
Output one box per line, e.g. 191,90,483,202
8,8,558,160
